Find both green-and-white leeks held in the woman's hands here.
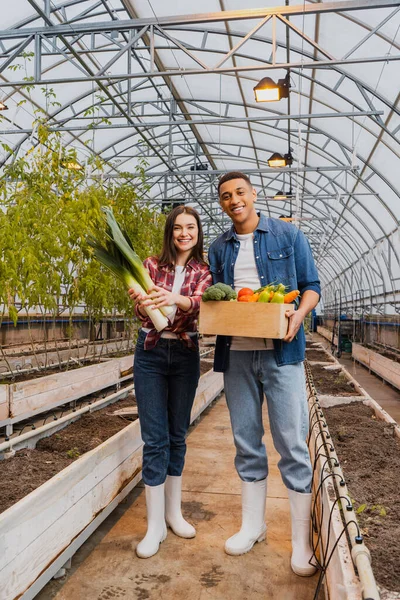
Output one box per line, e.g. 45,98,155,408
87,207,171,331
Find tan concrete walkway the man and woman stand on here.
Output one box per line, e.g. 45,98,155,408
37,397,317,600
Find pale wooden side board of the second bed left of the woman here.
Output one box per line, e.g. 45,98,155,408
0,355,133,435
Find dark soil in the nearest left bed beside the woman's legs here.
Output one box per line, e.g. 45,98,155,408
0,394,133,513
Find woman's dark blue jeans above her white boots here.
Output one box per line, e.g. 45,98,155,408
133,331,200,486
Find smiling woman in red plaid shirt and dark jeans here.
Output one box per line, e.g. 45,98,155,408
129,206,211,558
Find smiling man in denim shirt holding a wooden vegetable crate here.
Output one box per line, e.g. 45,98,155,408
209,172,320,576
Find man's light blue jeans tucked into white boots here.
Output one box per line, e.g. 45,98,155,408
224,350,312,493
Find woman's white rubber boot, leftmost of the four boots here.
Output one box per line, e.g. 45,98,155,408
136,483,167,558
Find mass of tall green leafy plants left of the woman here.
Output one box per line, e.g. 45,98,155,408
0,104,165,370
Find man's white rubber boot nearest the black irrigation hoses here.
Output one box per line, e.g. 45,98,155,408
288,490,316,577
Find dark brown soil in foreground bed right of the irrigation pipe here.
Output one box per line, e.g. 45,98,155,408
324,402,400,591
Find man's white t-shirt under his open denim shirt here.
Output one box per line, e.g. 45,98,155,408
231,233,274,350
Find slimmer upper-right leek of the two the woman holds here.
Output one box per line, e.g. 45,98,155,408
102,206,172,317
